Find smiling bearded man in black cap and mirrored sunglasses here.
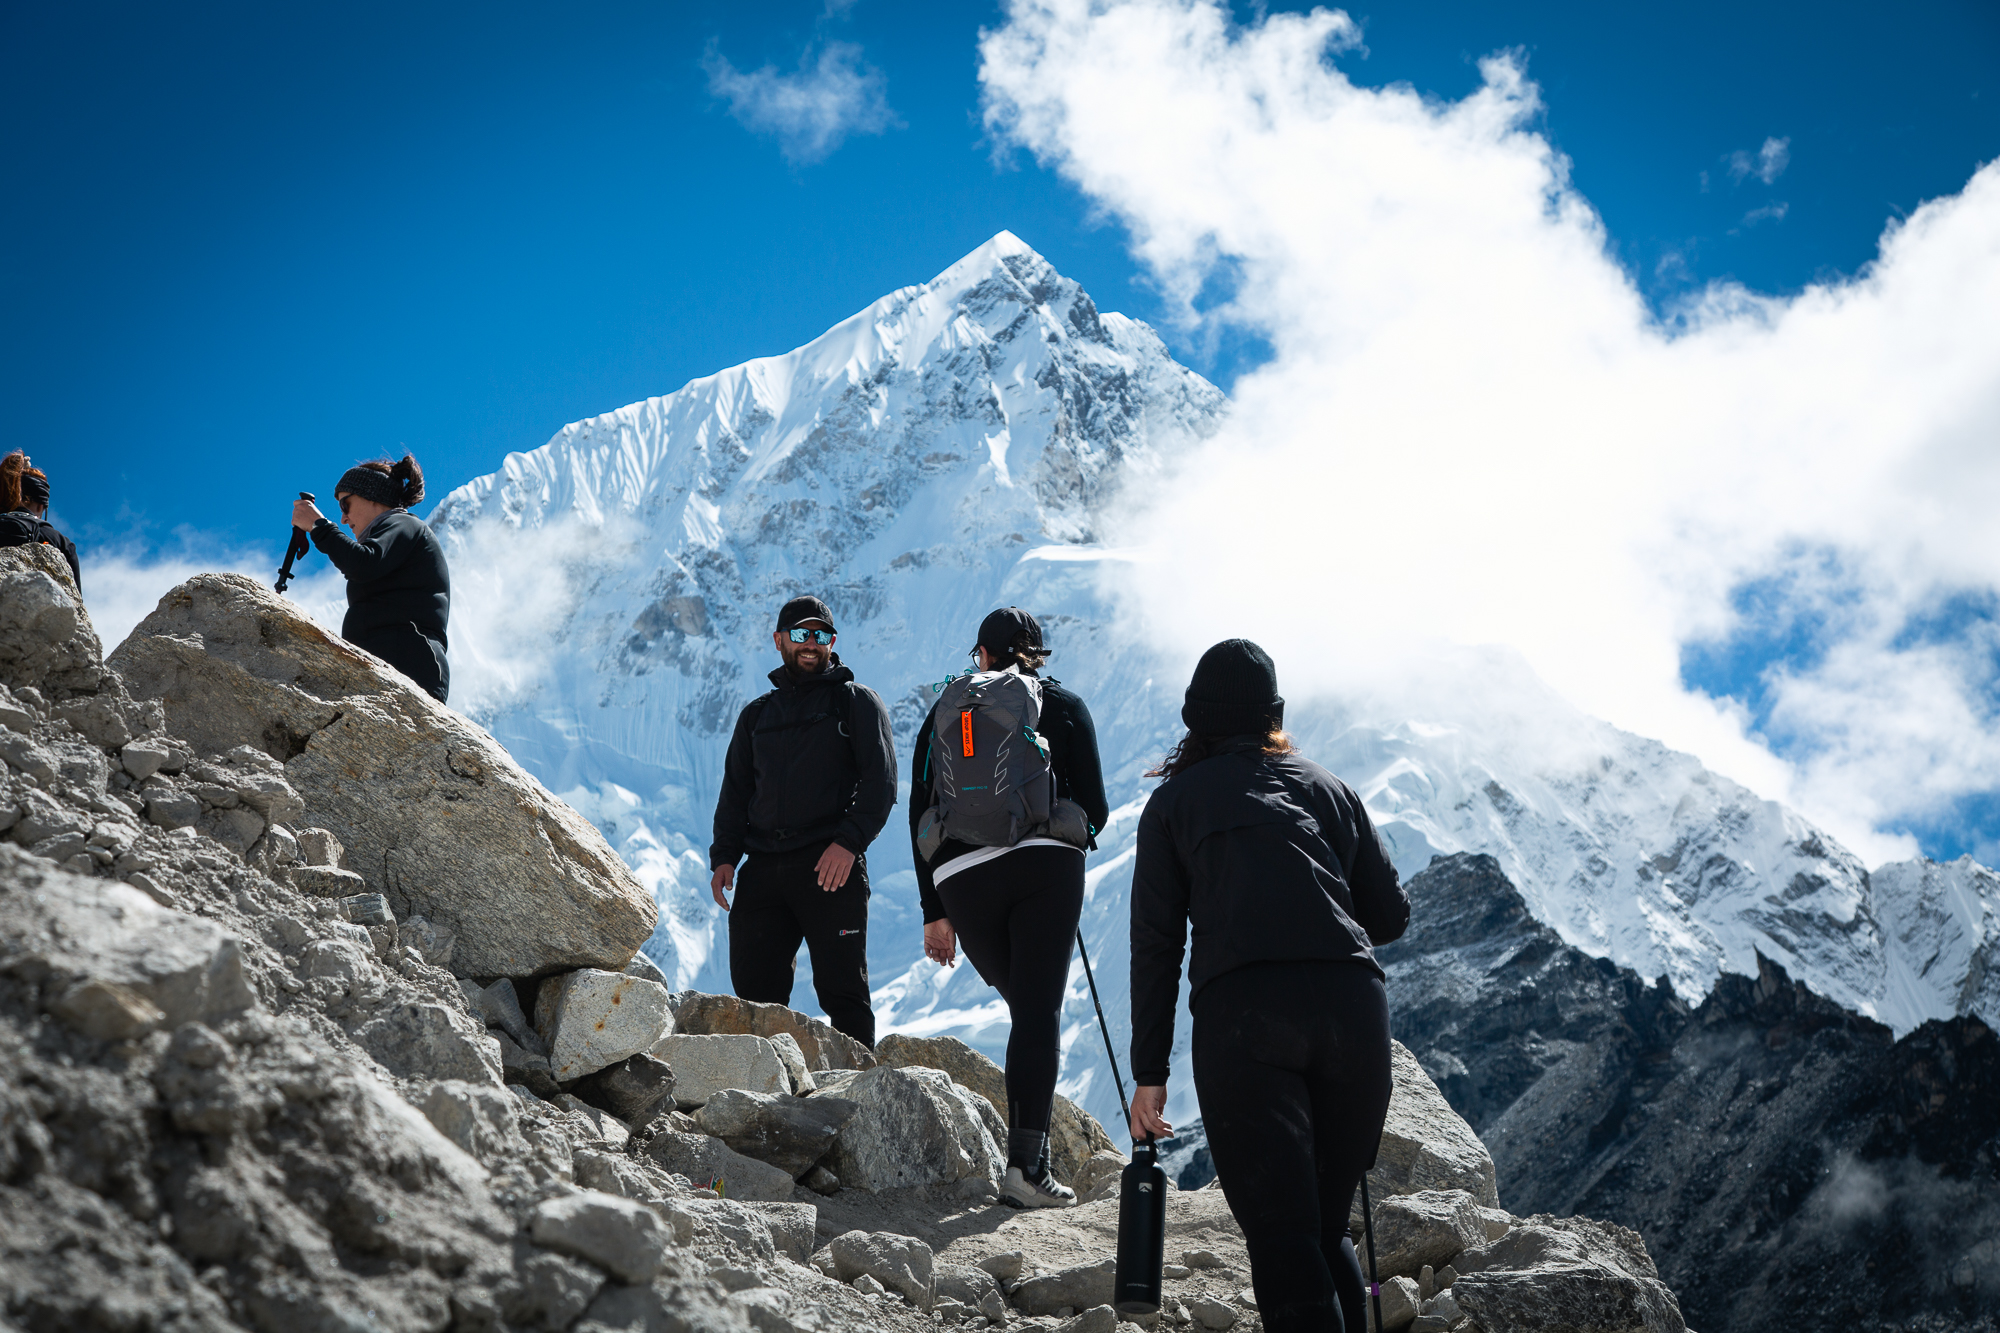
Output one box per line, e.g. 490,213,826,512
708,596,896,1047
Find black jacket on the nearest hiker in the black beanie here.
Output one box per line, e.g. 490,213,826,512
1132,737,1410,1087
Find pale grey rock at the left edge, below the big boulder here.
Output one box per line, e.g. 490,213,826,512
0,845,256,1027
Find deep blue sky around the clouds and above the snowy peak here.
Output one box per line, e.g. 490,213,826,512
11,0,2000,857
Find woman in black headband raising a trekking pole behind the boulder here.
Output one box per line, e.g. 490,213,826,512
292,454,452,703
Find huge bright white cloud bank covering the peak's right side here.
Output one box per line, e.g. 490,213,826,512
982,0,2000,857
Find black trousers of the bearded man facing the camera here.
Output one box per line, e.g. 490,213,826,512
730,843,874,1049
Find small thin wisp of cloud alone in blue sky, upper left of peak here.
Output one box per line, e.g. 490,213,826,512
702,40,900,164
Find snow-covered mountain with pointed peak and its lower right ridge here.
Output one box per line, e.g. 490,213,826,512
432,232,2000,1121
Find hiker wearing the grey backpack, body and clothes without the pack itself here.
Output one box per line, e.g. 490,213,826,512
910,606,1110,1207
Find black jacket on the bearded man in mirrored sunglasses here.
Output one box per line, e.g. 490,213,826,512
708,652,896,871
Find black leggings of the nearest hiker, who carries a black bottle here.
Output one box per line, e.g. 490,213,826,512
1194,961,1390,1333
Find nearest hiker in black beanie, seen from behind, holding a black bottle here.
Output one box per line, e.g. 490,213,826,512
1132,638,1410,1333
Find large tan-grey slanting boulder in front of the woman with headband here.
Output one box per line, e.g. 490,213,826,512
110,574,658,977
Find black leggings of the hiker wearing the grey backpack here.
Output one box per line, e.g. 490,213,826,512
938,847,1084,1135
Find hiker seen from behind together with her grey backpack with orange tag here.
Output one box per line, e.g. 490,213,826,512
910,606,1110,1207
